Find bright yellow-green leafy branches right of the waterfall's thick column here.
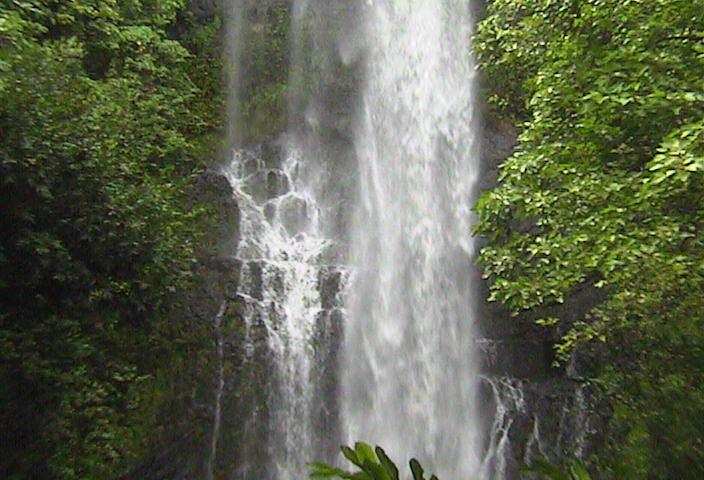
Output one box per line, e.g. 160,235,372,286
476,0,704,480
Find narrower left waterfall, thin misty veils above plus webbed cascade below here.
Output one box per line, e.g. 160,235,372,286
219,0,354,480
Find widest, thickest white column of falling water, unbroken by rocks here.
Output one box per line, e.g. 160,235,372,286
341,0,487,480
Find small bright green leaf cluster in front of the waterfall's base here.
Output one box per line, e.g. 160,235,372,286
310,442,438,480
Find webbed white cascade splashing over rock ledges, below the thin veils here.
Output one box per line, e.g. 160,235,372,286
223,148,329,479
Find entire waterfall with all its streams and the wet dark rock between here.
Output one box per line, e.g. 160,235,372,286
214,0,598,480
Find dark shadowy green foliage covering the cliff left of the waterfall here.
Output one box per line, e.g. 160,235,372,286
0,0,223,479
